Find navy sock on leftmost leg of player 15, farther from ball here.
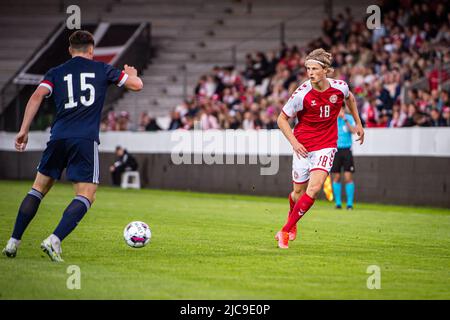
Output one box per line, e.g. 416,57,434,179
11,188,44,240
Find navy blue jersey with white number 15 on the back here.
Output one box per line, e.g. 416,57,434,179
39,57,128,143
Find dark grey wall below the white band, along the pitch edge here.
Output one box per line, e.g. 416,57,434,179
0,151,450,208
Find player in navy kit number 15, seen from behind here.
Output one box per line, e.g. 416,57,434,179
3,30,143,262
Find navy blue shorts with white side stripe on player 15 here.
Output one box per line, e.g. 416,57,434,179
38,138,99,184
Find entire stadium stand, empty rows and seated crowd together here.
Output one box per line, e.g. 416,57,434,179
0,0,450,130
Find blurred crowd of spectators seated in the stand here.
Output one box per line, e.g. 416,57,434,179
102,1,450,131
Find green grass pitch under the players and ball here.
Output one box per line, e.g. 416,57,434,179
0,181,450,299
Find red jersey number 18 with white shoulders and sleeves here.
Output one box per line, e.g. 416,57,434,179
282,78,349,152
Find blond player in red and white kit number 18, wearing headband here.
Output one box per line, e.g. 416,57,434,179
275,49,364,249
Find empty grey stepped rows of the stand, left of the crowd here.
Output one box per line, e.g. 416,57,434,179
106,0,374,128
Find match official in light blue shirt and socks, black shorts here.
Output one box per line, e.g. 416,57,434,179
331,107,356,210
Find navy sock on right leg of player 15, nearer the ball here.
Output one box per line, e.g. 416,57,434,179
53,196,91,241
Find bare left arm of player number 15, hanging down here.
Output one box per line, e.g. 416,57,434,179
15,86,51,151
